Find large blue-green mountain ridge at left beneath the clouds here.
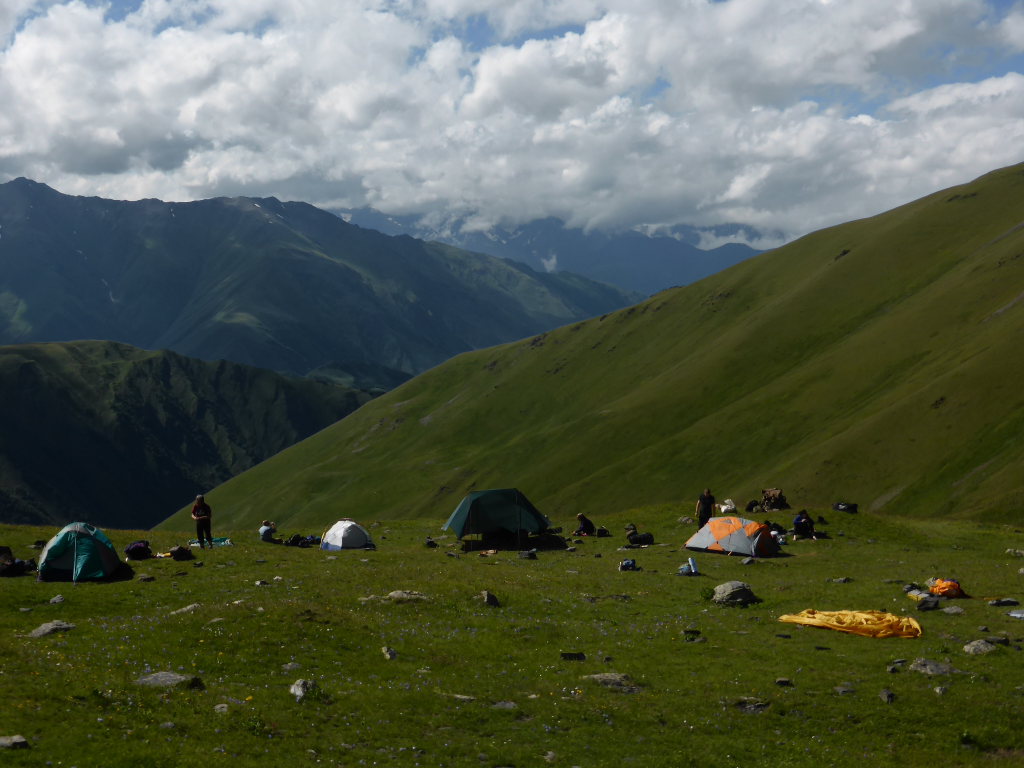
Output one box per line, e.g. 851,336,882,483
0,179,638,389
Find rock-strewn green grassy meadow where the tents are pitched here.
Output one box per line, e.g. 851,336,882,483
0,512,1024,768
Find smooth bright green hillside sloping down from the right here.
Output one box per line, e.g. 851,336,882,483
164,166,1024,528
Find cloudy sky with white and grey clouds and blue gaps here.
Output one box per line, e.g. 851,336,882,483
0,0,1024,244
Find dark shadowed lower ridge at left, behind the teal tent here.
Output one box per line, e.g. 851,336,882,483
0,341,370,528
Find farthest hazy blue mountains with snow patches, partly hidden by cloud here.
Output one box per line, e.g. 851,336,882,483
337,208,762,296
